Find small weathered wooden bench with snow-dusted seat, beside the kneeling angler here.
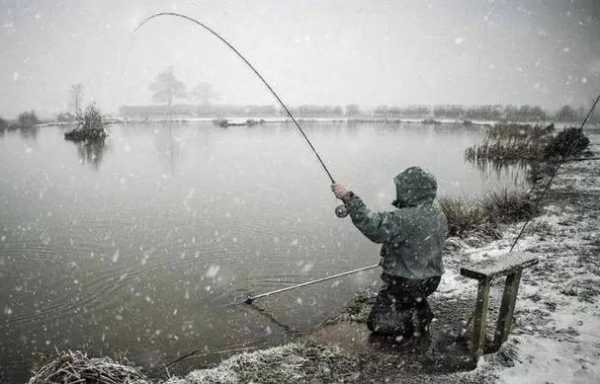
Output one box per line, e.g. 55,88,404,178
460,252,539,357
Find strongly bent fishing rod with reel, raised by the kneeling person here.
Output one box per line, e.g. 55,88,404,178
134,12,348,218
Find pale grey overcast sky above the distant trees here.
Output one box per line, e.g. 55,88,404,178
0,0,600,117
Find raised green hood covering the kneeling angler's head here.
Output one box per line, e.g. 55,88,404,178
392,167,437,208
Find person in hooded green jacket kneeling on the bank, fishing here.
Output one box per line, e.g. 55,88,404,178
332,167,448,338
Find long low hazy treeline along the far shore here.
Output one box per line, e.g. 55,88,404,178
119,104,600,122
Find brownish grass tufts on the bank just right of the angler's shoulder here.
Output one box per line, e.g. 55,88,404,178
440,189,535,238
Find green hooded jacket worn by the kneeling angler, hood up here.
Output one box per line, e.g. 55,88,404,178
344,167,448,279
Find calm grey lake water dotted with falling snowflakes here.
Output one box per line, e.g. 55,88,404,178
0,123,522,383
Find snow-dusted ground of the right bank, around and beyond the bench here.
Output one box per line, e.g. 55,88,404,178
440,148,600,383
